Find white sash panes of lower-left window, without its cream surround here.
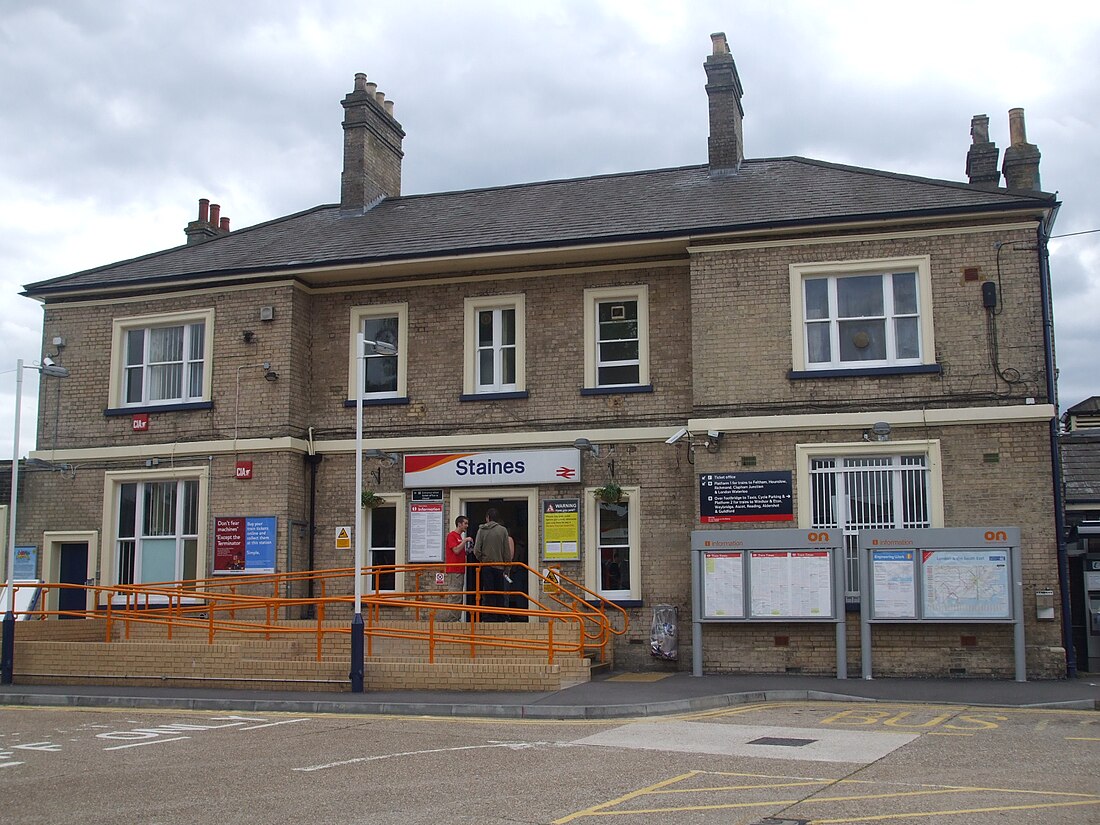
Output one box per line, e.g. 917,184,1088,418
116,479,199,584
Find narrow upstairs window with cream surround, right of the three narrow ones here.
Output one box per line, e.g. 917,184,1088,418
584,284,649,389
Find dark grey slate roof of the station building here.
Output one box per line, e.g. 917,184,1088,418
25,157,1055,297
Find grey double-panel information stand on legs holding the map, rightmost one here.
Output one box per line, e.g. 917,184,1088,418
859,527,1027,682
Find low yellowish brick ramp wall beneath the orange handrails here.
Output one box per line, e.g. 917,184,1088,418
8,622,591,692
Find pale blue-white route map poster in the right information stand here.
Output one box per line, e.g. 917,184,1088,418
921,550,1012,619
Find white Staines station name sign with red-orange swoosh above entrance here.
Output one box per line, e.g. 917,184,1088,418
405,448,581,487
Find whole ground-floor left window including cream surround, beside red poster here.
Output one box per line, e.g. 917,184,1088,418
103,468,207,584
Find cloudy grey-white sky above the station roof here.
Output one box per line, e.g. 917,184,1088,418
0,0,1100,459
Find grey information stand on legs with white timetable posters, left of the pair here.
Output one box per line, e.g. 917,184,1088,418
691,529,848,679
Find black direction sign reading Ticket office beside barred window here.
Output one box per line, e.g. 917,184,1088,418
699,471,794,524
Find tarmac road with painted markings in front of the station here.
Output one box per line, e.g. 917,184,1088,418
0,700,1100,825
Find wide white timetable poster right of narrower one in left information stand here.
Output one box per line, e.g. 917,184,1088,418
749,550,833,618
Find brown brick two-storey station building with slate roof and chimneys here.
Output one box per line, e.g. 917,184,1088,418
18,34,1066,678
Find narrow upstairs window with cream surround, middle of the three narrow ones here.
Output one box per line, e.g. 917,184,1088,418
462,295,527,395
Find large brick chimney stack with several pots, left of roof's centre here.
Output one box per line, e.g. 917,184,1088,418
340,73,405,211
